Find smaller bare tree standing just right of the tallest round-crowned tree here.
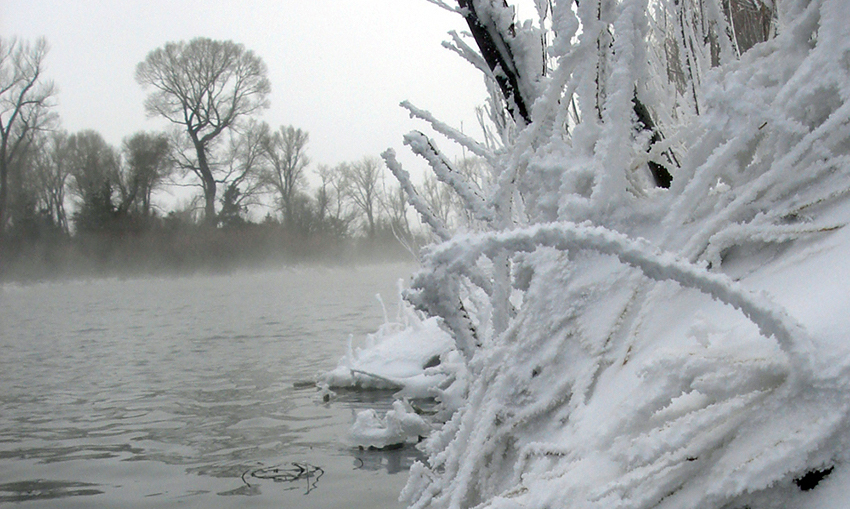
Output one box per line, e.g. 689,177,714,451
263,126,310,228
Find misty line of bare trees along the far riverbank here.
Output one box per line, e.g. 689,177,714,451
0,38,440,278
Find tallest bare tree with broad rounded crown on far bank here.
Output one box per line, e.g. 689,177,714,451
136,38,271,225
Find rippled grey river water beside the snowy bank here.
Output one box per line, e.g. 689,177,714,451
0,264,418,509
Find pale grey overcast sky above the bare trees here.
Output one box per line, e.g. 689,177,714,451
0,0,485,185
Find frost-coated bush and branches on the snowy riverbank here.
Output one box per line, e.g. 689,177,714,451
384,0,850,509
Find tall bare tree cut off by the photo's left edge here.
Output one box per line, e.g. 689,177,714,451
0,37,55,233
